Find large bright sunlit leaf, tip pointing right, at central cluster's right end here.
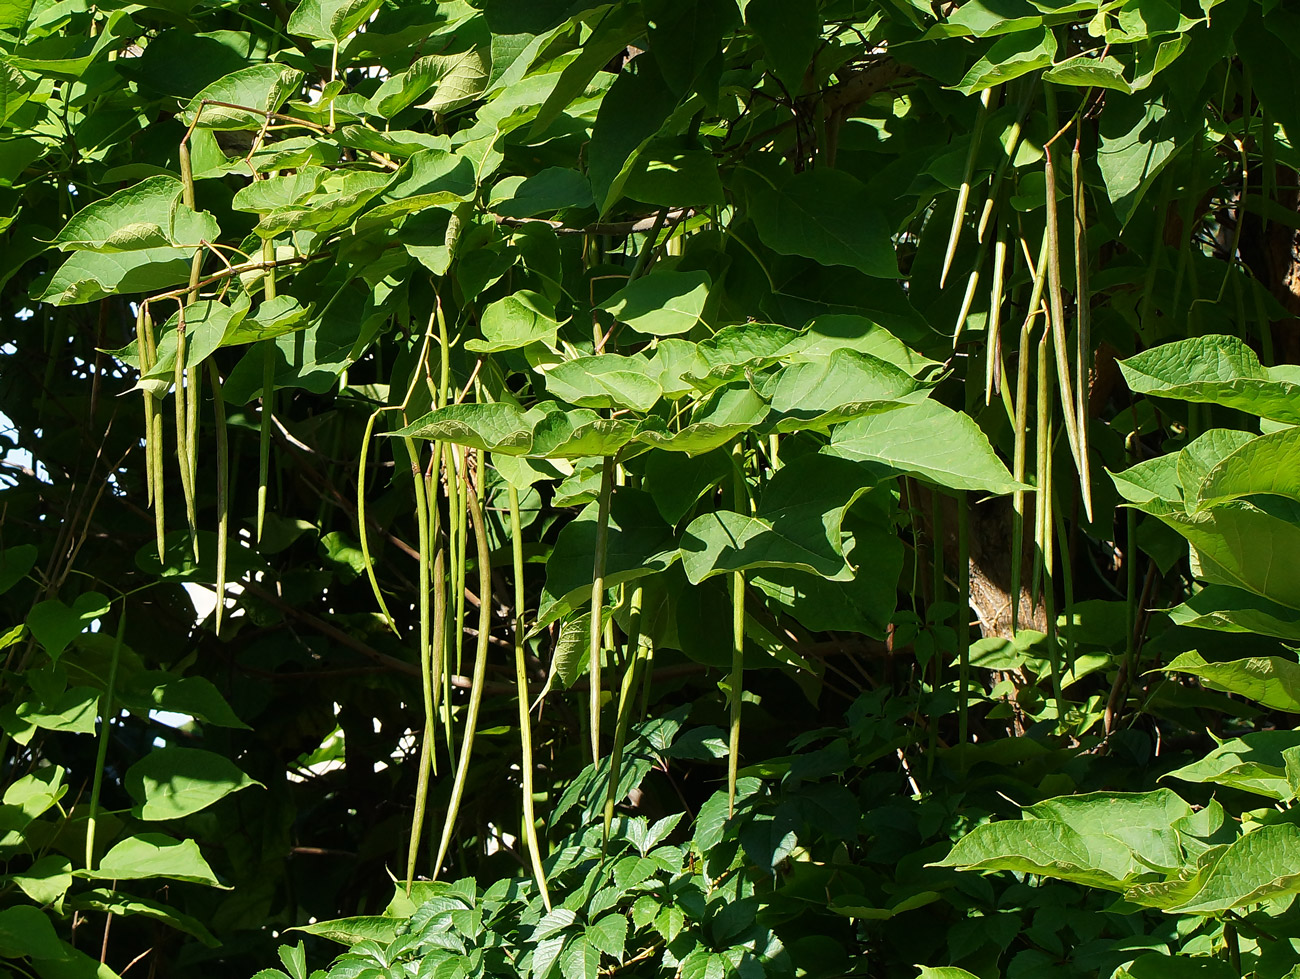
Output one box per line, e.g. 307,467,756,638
827,400,1026,494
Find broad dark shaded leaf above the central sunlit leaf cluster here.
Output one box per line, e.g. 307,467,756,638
750,168,900,278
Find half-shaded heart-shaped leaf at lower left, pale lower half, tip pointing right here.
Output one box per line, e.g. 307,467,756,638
122,748,261,822
